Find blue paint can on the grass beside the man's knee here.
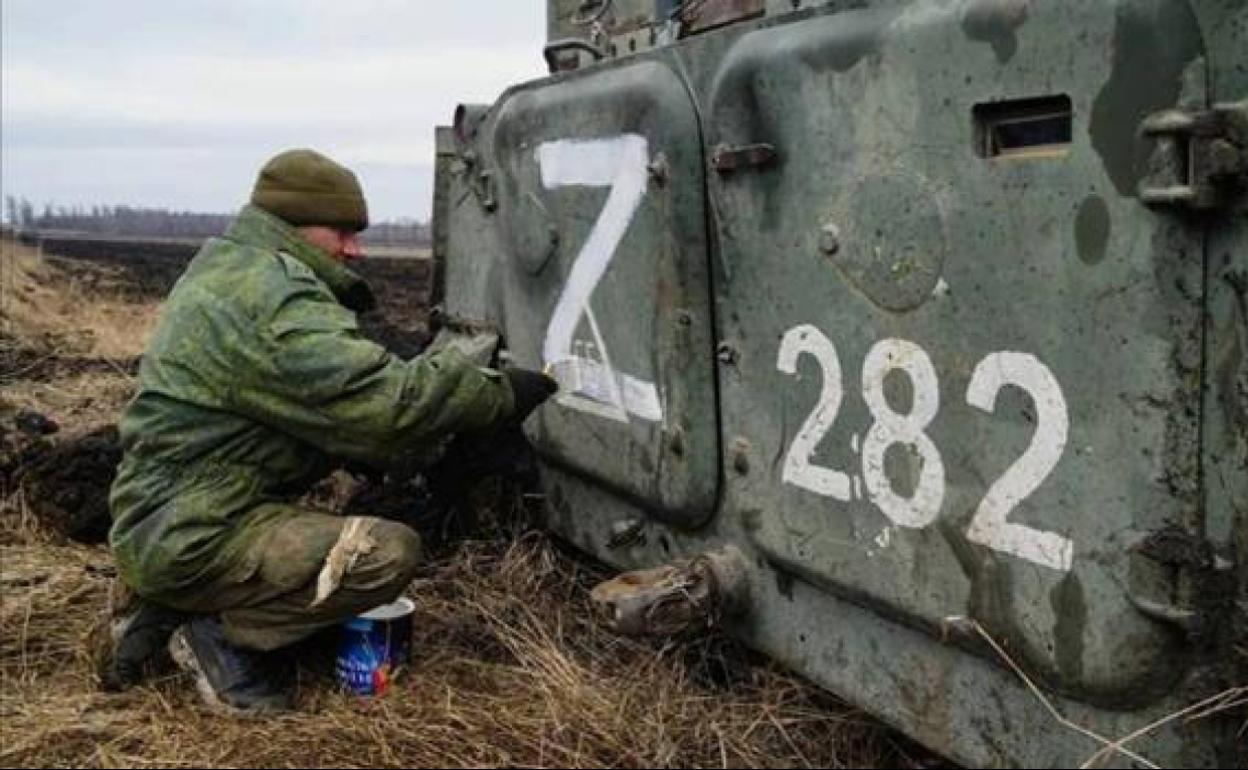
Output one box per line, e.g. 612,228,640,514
334,597,416,695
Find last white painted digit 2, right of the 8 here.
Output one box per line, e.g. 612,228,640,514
966,351,1073,572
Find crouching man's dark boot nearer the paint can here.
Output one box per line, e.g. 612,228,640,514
168,615,295,715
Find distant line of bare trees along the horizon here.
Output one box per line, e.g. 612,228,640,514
5,195,429,246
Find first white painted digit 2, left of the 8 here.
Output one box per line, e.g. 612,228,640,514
776,323,850,500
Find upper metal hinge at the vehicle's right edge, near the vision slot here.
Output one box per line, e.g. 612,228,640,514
1139,100,1248,210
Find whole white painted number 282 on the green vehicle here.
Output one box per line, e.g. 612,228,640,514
776,323,1073,572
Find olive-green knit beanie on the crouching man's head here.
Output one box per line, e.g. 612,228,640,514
251,150,368,231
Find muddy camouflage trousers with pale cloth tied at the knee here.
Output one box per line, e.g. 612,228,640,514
158,507,421,650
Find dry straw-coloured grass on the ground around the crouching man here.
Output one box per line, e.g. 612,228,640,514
0,237,930,768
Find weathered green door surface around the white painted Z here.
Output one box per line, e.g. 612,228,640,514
448,61,719,528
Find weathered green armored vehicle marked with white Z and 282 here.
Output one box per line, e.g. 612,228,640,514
434,0,1248,766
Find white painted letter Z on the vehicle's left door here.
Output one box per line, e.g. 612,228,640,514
535,134,663,422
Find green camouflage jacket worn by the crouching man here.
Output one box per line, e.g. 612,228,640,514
110,206,513,605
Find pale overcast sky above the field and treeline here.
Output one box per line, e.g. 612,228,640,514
0,0,545,221
